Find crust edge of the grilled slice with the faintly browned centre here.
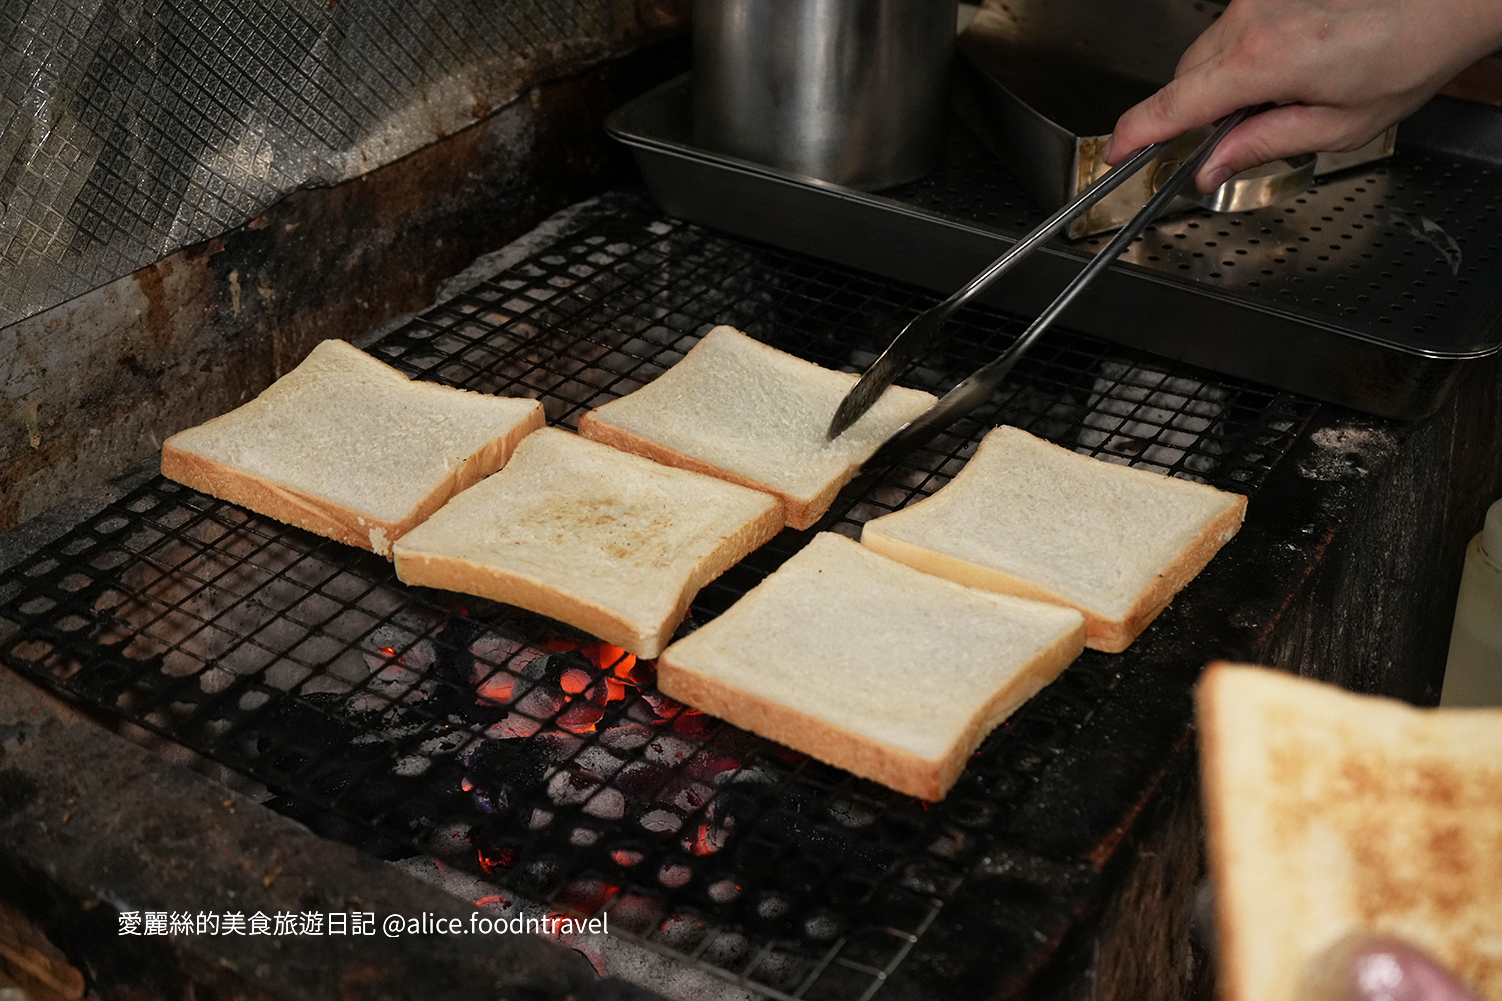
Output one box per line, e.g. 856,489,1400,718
395,486,783,658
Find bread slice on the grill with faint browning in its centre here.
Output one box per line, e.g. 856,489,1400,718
395,428,783,657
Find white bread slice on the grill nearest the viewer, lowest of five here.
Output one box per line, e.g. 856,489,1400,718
658,532,1084,800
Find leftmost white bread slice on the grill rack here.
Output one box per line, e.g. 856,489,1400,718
162,340,544,556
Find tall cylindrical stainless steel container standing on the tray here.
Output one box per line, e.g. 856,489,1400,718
694,0,957,191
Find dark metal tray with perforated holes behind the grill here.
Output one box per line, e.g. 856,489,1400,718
608,77,1502,419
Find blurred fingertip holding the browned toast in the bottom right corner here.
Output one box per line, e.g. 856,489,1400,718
1301,935,1476,1001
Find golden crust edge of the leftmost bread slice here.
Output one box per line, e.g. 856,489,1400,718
162,404,545,558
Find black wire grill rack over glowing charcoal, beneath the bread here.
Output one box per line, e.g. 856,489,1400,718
0,197,1316,998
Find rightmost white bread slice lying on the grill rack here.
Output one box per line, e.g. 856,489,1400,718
861,425,1247,654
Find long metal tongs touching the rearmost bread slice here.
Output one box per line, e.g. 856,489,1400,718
828,105,1269,470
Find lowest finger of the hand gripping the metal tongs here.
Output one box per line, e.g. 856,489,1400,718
1194,104,1382,194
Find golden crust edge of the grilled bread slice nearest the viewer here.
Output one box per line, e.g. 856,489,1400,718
658,613,1084,801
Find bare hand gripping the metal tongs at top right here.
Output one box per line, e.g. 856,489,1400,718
1104,0,1502,192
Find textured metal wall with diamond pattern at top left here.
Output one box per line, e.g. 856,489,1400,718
0,0,655,326
